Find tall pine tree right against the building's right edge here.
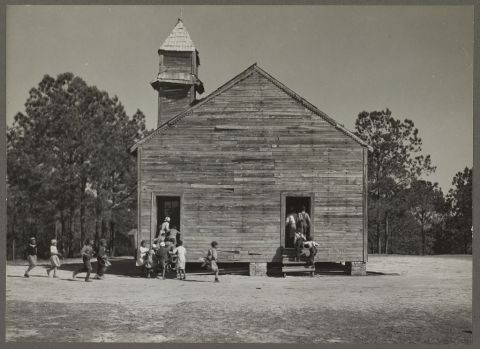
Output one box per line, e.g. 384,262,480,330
355,109,435,253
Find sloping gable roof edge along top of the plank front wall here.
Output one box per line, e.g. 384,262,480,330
130,63,372,152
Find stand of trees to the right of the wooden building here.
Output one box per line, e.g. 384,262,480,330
355,109,472,254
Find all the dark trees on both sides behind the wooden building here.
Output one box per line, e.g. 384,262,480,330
7,73,472,257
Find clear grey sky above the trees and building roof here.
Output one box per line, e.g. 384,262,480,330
6,5,473,192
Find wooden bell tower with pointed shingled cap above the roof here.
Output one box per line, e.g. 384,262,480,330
150,18,204,127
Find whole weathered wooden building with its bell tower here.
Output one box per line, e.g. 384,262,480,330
131,19,368,275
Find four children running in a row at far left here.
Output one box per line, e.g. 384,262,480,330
24,237,110,282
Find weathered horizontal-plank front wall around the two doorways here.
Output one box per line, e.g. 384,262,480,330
138,72,364,261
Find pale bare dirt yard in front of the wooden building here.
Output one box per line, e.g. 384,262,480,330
6,256,472,344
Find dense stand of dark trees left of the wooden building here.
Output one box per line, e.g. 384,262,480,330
7,73,147,257
